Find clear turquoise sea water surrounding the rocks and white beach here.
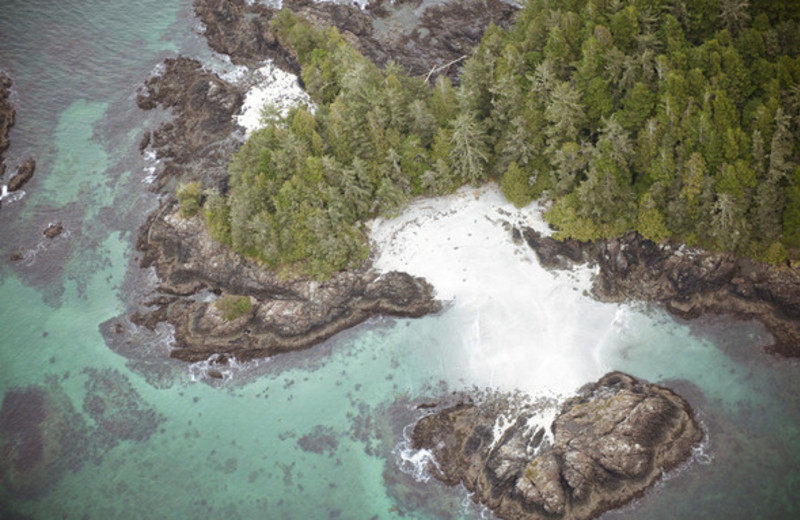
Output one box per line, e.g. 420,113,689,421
0,0,800,519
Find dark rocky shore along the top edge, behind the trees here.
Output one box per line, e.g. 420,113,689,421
194,0,517,80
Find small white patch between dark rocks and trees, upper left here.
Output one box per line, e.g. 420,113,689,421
234,63,311,136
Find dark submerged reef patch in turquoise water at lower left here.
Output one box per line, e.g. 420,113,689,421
0,368,165,499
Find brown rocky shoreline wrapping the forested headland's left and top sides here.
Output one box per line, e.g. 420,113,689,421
126,0,515,362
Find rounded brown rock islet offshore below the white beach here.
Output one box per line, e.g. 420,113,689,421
411,372,703,520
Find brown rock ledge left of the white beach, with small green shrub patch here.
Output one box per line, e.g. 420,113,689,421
133,199,441,361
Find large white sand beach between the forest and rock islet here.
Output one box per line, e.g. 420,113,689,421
371,185,618,396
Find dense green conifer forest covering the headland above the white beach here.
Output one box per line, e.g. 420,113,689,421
189,0,800,277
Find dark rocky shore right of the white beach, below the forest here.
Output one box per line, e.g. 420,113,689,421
522,229,800,357
